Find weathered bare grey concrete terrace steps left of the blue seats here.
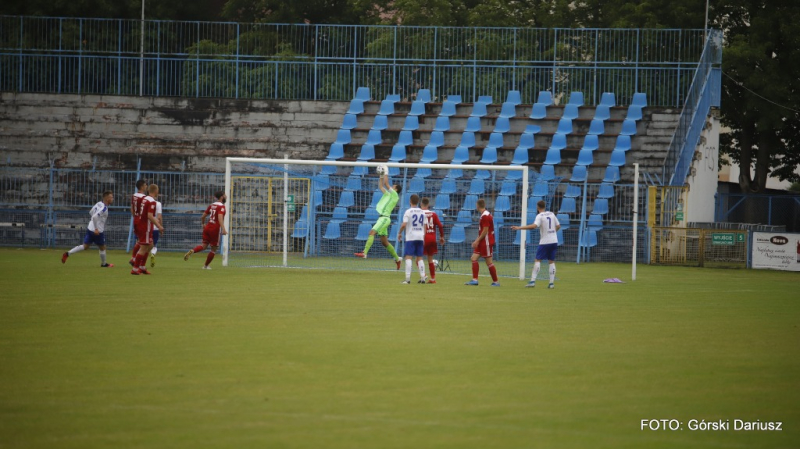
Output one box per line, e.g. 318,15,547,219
0,93,348,172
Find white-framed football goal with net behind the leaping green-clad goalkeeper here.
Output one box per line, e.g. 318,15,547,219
223,158,538,279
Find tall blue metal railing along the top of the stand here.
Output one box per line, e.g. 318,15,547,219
0,16,715,107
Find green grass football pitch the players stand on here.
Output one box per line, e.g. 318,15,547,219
0,249,800,449
